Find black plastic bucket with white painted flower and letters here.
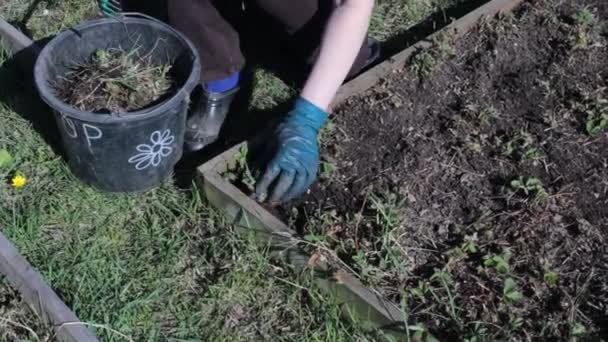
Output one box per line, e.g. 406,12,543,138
34,16,201,192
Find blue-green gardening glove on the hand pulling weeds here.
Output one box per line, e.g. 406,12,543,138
256,97,327,202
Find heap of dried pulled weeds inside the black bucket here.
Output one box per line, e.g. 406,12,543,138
54,49,173,114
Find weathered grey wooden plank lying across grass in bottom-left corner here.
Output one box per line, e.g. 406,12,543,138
0,233,97,342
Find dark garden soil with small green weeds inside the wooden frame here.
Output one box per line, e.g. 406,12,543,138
279,0,608,341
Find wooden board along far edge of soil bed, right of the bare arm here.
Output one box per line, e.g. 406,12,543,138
330,0,525,108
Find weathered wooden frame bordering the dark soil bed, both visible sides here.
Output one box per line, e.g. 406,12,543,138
197,0,524,340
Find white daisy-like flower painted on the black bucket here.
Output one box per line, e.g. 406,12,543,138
129,129,175,170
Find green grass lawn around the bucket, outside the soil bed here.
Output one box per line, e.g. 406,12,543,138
0,0,472,341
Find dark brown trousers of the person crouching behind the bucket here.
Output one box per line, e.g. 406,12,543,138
168,0,370,82
